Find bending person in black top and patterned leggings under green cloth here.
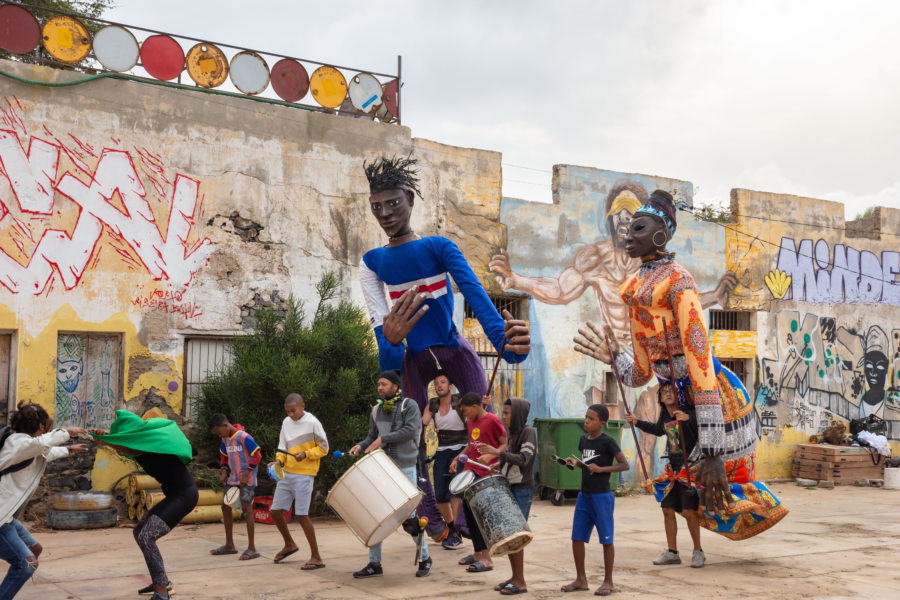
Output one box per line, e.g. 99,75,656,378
92,411,199,600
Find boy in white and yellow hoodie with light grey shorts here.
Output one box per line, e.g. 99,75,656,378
271,394,328,571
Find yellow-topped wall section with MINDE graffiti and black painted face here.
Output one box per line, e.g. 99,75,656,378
727,190,900,476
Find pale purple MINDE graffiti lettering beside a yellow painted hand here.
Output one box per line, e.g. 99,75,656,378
767,237,900,305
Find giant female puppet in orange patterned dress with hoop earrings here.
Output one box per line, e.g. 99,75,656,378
575,190,788,539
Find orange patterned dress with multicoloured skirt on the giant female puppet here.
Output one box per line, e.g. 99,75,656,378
615,255,788,539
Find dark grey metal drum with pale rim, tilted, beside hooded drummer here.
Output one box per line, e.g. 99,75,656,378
465,475,534,556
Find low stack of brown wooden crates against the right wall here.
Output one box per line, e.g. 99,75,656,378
791,444,884,485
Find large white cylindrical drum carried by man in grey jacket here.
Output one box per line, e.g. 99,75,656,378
325,448,424,547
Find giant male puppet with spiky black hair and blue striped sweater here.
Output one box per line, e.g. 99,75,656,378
359,157,531,540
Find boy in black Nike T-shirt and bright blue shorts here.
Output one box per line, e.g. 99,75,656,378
561,404,628,596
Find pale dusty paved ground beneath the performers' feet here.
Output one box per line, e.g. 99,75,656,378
8,483,900,600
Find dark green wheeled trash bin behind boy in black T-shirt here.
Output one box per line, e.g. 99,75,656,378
534,418,625,505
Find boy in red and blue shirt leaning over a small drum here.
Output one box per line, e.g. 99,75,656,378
209,414,262,560
